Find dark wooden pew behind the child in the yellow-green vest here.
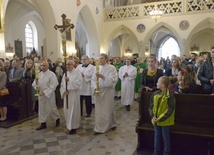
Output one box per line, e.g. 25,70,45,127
136,92,214,155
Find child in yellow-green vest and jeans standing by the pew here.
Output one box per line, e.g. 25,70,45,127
149,76,175,155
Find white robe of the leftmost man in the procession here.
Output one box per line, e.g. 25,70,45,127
32,69,60,123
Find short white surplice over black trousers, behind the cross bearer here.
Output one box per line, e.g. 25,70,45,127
76,64,95,96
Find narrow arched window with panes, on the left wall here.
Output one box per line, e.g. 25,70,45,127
25,23,34,53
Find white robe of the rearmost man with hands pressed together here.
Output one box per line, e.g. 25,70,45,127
119,65,137,105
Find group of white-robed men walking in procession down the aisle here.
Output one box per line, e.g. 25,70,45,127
32,54,139,135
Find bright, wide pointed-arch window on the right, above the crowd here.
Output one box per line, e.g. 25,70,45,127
158,36,180,60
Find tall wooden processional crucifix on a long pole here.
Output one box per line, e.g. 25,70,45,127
54,14,74,109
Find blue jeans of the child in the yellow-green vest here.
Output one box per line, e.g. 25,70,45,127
154,124,170,154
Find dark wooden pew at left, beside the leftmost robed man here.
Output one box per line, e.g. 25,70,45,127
0,80,63,128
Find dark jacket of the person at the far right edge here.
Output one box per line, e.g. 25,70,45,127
198,60,214,93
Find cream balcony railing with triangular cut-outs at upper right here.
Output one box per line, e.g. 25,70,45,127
104,0,214,21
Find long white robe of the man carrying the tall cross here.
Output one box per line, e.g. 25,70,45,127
60,68,82,130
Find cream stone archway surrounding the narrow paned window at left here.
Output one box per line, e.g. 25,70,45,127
5,0,56,59
